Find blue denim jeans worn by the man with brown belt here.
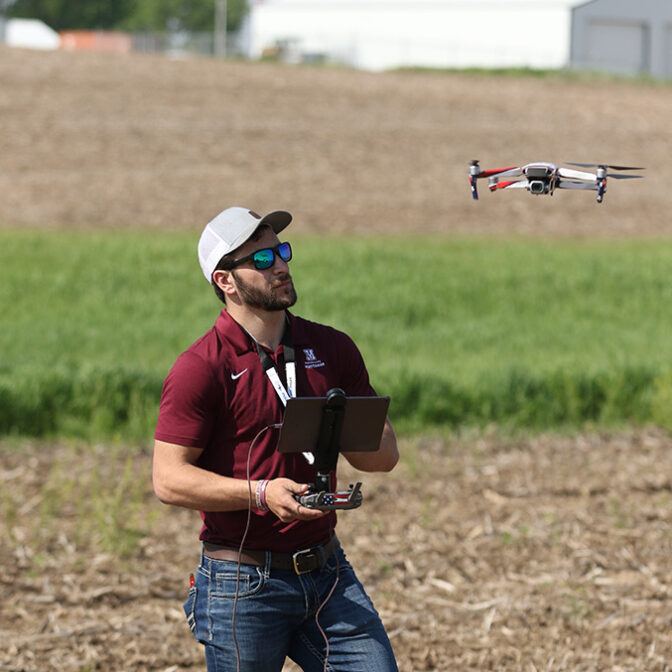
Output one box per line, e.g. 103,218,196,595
184,544,397,672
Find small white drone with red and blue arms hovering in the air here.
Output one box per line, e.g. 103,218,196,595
469,160,644,203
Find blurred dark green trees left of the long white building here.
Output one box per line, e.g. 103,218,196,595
0,0,247,32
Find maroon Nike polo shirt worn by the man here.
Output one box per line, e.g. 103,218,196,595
155,310,375,552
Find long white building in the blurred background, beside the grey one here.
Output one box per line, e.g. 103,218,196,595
247,0,586,70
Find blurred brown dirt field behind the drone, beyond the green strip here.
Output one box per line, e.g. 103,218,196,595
0,50,672,236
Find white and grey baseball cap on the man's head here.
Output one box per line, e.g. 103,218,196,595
198,207,292,282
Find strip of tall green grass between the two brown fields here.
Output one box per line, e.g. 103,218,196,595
0,230,672,440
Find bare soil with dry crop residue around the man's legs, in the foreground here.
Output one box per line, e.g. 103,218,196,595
0,431,672,672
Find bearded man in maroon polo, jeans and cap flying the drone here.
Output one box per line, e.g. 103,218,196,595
153,207,399,672
